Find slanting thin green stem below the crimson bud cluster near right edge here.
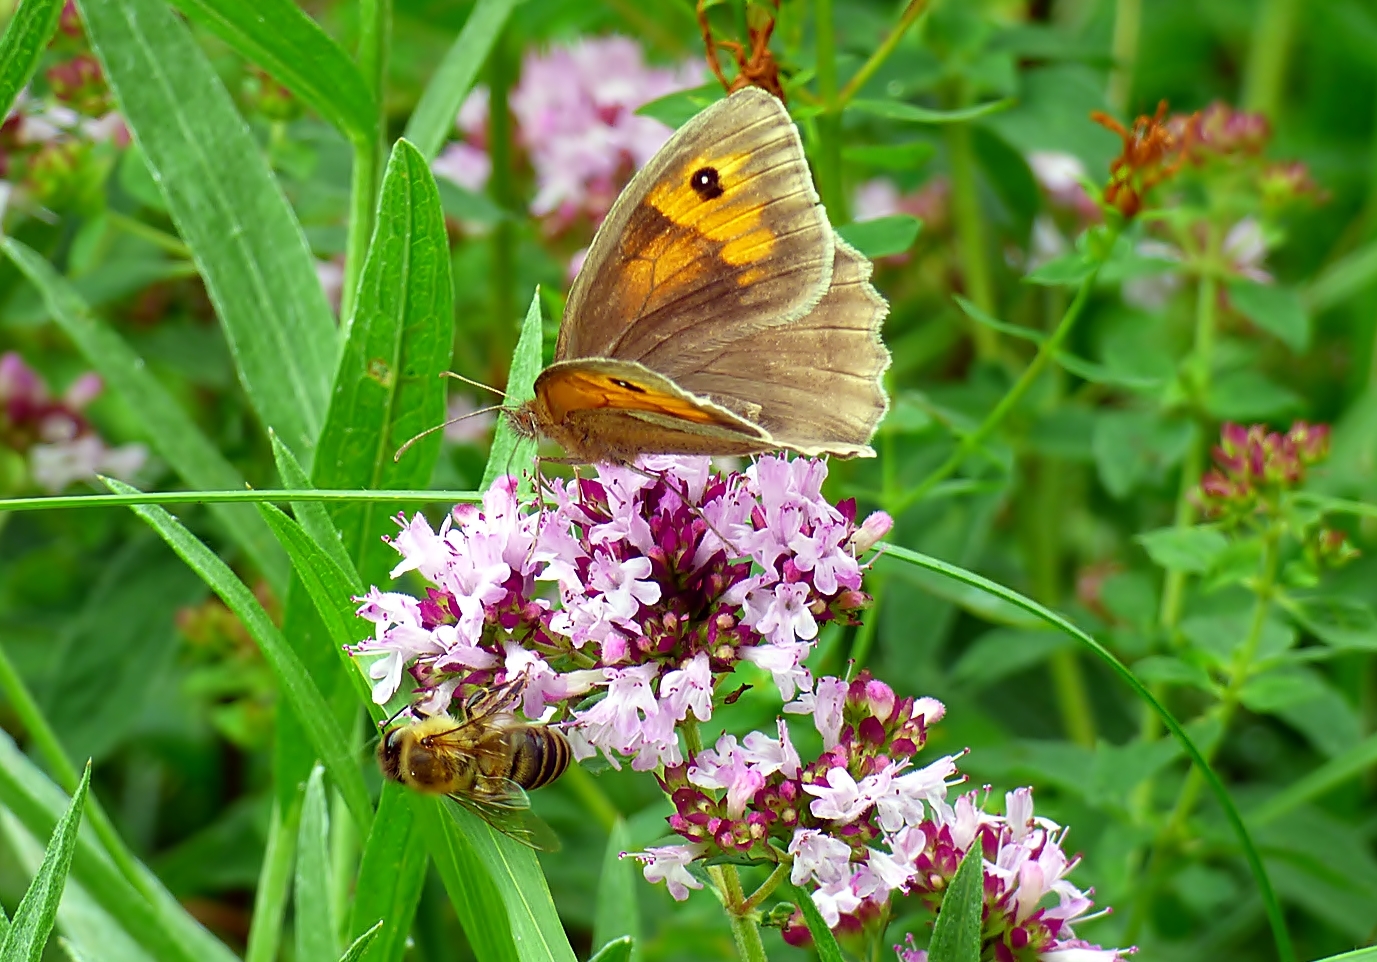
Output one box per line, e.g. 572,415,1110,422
1125,523,1281,941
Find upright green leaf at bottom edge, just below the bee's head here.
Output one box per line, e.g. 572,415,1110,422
348,782,430,962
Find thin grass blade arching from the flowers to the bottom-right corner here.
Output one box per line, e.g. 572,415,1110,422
877,544,1296,959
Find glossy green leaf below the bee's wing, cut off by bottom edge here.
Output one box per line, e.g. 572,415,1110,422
412,793,574,962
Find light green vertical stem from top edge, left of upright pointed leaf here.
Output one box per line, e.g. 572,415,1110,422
340,0,392,327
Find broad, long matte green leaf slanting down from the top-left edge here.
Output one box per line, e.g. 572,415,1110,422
81,0,339,462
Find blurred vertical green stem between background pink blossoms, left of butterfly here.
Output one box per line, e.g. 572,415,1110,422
487,22,519,384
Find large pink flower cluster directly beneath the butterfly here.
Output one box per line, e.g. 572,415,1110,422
354,457,888,771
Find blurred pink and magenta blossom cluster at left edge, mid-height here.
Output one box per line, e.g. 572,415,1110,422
0,351,147,493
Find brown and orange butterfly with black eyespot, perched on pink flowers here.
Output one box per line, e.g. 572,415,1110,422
508,87,890,464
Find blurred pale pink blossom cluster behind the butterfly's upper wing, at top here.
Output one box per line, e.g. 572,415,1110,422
434,36,702,231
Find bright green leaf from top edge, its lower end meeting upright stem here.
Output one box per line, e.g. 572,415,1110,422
161,0,379,143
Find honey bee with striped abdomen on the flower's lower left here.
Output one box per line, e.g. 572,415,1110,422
377,677,571,851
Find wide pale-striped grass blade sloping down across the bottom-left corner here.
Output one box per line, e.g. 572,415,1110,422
0,732,237,962
